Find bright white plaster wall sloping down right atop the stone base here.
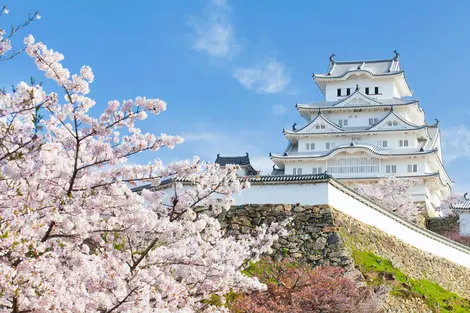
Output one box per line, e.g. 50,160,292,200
328,185,470,268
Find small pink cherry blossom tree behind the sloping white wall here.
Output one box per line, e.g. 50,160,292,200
355,177,424,222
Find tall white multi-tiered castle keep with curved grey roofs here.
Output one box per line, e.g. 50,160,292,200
270,51,452,210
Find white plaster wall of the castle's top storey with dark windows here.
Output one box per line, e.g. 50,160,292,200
325,74,397,101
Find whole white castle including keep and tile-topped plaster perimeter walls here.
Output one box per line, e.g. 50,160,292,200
140,53,470,268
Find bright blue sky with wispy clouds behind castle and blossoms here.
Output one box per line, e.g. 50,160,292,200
0,0,470,191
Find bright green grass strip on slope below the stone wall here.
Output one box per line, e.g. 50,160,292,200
353,250,470,313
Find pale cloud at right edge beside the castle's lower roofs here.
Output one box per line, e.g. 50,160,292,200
442,125,470,162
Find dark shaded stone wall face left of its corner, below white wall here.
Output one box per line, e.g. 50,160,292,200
221,204,352,267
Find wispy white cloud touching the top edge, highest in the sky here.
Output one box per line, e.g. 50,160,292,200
190,0,240,58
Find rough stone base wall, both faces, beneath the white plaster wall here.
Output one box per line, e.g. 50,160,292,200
220,204,470,313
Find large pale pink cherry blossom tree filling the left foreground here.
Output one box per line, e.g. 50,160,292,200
0,9,282,313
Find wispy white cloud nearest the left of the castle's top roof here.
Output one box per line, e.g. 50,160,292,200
233,59,290,93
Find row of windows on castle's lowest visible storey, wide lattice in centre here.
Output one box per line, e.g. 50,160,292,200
292,163,418,175
